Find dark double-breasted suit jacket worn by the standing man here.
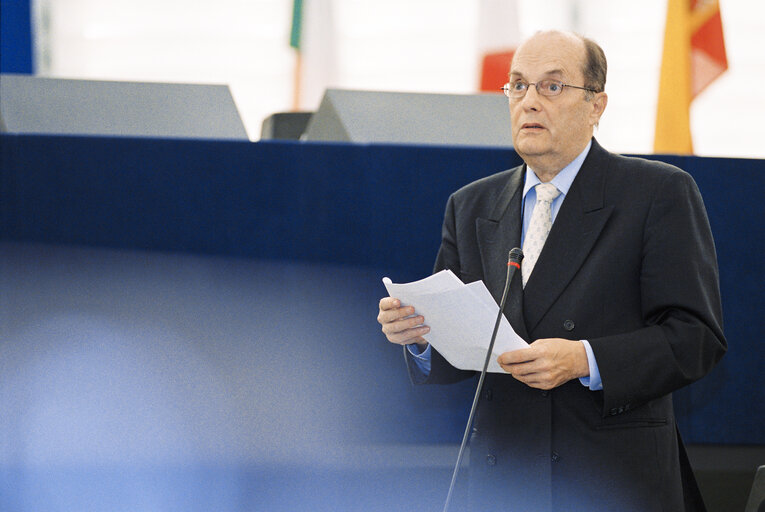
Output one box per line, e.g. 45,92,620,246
409,140,727,512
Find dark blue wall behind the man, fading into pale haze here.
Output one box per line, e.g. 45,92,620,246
0,135,765,510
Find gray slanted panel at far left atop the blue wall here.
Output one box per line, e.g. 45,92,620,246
0,74,248,140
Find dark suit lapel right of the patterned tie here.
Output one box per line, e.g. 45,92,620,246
523,140,613,331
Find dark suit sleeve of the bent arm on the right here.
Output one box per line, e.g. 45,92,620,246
589,170,727,415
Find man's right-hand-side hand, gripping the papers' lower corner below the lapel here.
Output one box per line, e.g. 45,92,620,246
497,338,590,389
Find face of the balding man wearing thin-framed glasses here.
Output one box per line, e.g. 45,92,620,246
510,33,605,174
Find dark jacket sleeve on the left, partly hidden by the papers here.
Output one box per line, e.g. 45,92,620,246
404,195,475,384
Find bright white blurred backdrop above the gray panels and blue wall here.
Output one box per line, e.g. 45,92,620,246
3,0,765,157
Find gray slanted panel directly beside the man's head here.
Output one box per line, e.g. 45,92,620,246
303,89,512,147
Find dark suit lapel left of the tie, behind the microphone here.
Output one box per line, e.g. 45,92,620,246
476,166,528,339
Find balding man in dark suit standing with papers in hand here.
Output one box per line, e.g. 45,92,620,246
378,32,727,512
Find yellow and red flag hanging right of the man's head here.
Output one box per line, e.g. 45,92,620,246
653,0,728,154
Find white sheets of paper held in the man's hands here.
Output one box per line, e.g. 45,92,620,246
383,270,528,373
